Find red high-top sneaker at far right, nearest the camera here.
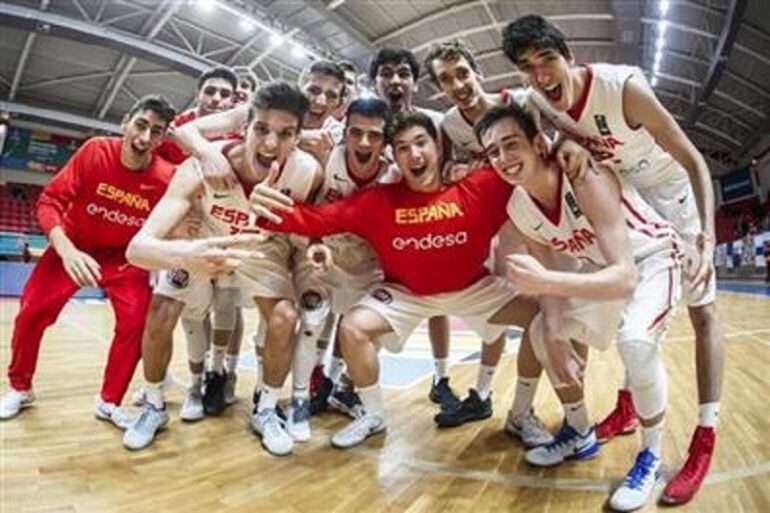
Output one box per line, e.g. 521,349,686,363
661,426,717,505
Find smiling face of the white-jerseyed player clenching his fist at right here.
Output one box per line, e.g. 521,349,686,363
481,117,546,187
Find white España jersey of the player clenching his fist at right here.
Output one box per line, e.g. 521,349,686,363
507,173,682,268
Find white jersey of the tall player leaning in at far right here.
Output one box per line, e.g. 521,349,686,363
531,63,687,189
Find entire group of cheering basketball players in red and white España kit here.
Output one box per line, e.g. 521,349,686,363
0,16,723,511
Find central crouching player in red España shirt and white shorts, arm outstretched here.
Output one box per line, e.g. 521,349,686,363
251,112,536,448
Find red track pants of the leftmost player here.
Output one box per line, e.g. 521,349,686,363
8,247,152,404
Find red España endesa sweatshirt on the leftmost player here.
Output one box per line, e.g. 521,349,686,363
37,137,174,253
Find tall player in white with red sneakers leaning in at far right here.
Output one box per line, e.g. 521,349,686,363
503,16,723,504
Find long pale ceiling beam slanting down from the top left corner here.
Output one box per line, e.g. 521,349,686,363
0,3,213,76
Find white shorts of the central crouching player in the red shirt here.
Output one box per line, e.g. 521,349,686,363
356,276,516,353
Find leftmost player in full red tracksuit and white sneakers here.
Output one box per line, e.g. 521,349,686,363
0,96,174,428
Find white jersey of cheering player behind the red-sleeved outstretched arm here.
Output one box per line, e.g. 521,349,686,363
318,145,401,275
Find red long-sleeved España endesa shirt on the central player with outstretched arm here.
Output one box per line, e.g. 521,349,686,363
260,167,513,295
